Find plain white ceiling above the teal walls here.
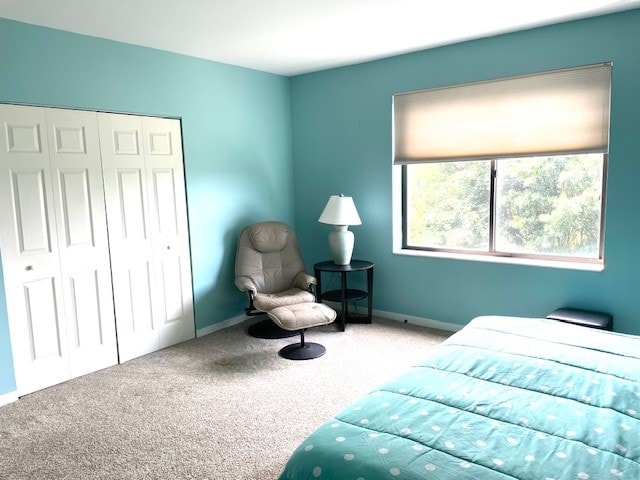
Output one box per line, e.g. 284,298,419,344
0,0,640,76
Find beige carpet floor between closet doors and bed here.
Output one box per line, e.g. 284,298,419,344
0,319,450,480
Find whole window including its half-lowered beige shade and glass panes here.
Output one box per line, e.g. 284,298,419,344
394,64,611,263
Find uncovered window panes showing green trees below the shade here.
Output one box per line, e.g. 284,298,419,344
403,154,605,260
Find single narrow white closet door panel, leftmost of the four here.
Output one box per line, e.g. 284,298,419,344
0,105,70,395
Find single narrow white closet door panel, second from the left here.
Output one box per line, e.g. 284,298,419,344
46,109,118,377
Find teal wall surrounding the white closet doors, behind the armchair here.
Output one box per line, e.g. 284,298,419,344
0,19,294,395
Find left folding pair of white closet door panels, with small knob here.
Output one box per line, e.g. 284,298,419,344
0,105,118,395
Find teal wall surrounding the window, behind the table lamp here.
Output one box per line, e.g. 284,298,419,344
291,10,640,334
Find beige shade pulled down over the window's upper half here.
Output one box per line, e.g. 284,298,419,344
393,63,611,165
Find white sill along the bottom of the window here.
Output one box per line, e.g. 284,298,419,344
393,248,604,272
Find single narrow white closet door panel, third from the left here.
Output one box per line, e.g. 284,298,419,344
98,113,160,362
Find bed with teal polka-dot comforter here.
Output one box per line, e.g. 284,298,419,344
280,317,640,480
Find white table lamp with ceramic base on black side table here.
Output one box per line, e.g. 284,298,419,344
318,195,362,265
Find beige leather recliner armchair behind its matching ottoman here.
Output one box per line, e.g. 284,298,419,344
235,221,317,338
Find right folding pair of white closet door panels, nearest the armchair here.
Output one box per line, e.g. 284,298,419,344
99,113,195,361
